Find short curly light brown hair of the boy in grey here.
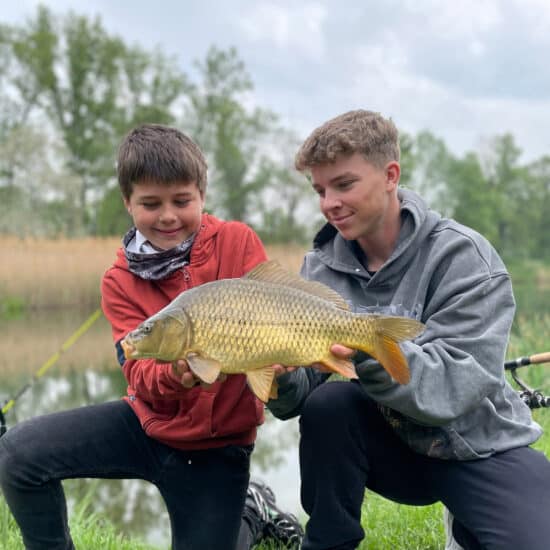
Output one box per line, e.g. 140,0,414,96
295,109,399,171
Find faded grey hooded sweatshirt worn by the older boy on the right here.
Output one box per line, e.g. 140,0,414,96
268,189,541,460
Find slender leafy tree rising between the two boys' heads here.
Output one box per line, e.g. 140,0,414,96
185,47,275,220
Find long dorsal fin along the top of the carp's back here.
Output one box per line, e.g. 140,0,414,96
243,260,349,310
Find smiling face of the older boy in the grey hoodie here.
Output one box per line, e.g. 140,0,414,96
310,153,400,249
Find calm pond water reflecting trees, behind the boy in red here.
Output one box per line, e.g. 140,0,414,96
0,312,303,548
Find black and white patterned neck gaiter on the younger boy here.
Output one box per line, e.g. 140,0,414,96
122,227,195,281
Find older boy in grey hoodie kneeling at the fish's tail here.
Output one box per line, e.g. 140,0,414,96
268,110,550,550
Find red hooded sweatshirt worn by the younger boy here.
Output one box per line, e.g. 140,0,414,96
101,214,266,449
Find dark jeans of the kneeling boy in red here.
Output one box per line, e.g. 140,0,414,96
0,400,251,550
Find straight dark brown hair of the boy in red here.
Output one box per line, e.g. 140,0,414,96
117,124,207,199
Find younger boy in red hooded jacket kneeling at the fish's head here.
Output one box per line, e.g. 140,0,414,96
0,124,302,550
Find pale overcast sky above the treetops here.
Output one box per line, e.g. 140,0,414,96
4,0,550,164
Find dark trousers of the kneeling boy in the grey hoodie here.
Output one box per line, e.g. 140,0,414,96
300,382,550,550
